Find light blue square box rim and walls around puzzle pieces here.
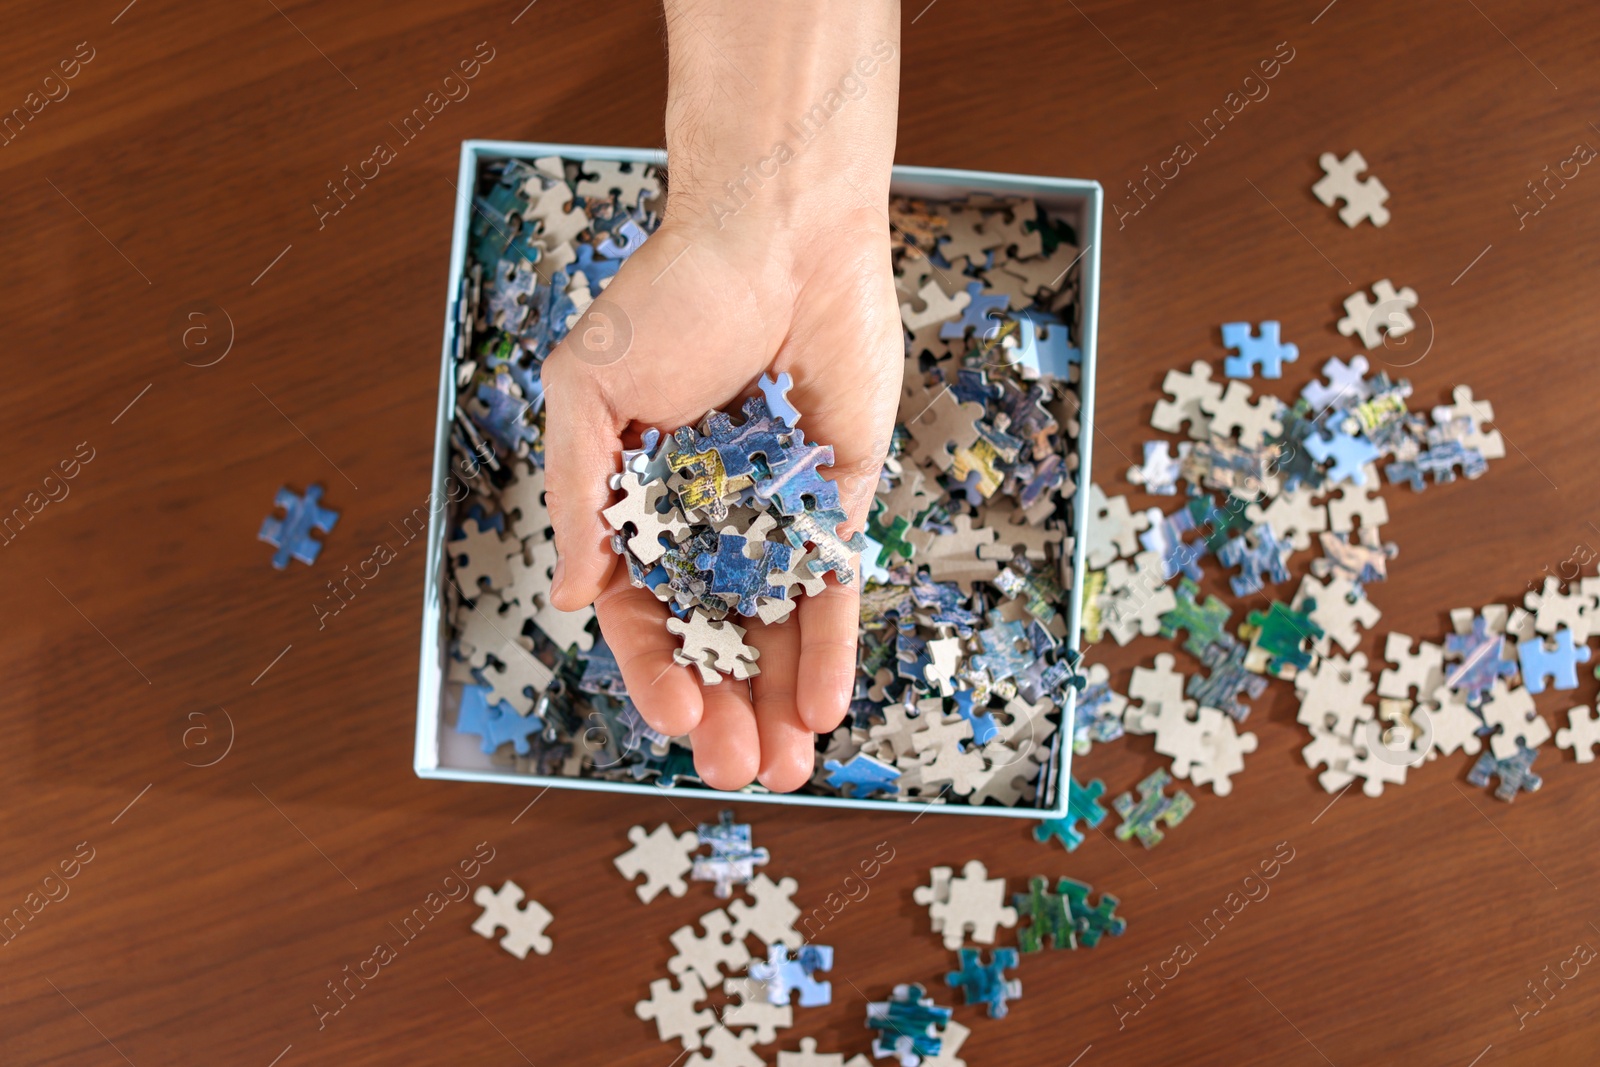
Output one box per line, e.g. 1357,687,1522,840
413,141,1104,819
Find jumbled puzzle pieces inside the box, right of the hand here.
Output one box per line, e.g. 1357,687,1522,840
813,197,1082,805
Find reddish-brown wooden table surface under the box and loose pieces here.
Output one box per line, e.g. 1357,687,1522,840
0,0,1600,1067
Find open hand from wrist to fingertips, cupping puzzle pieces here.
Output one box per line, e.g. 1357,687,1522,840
544,208,904,790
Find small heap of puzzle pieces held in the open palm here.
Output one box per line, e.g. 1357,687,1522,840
605,373,866,685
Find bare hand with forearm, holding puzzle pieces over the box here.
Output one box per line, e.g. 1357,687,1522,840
542,0,904,792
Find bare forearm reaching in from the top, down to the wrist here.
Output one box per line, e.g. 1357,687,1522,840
666,0,899,229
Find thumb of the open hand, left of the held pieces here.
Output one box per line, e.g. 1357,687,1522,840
541,342,622,611
